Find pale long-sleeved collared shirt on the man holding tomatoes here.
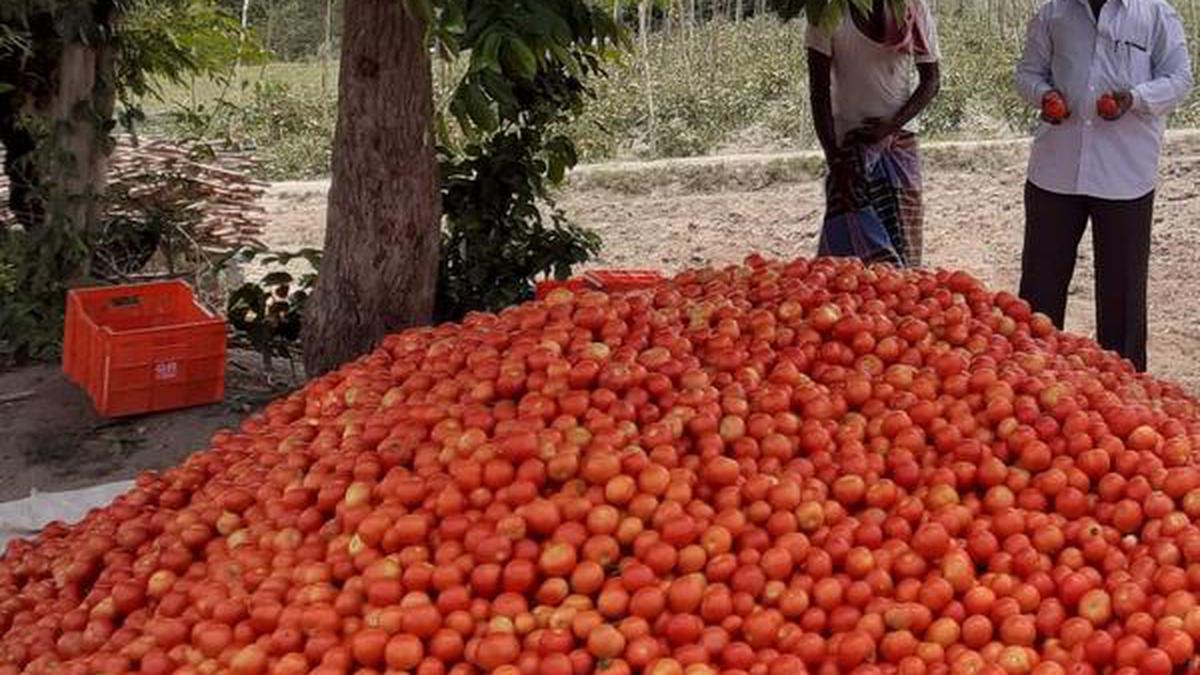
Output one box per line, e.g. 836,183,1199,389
1016,0,1192,199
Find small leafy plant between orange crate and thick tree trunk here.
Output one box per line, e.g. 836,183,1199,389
226,247,320,378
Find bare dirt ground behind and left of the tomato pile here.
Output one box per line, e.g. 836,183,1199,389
0,133,1200,501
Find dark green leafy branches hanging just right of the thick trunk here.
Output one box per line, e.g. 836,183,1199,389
404,0,629,319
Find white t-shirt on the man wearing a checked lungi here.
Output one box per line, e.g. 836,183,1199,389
808,0,941,143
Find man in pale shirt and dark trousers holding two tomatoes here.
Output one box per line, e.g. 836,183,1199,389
1016,0,1192,370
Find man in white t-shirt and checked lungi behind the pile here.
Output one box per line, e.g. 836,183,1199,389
808,0,940,267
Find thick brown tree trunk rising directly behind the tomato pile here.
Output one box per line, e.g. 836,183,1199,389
304,0,440,376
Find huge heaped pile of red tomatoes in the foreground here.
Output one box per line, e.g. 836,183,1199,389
0,257,1200,675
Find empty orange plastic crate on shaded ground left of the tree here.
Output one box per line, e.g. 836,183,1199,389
62,281,226,417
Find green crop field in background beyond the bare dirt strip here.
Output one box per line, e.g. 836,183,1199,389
146,7,1200,180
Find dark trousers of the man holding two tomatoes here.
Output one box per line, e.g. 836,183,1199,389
1020,183,1154,371
